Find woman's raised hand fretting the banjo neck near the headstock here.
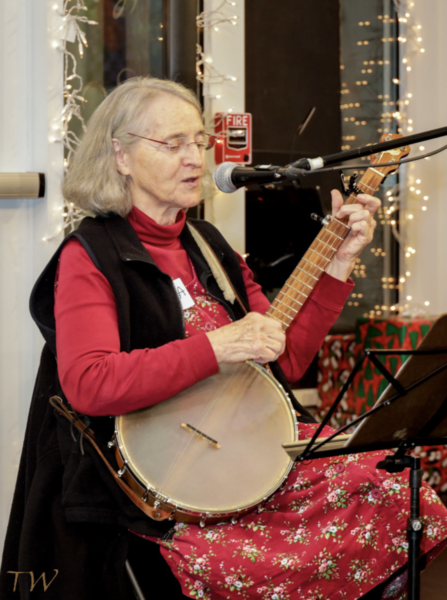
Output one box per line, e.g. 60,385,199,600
326,190,380,281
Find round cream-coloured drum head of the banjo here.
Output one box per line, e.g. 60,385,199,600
115,361,298,520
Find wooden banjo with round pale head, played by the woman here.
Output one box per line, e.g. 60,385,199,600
109,134,409,527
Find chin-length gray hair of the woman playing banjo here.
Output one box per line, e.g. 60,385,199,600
62,77,202,217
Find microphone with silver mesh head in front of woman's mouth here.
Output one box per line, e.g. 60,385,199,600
213,162,285,194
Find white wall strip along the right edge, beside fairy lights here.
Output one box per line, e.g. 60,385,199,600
401,0,447,314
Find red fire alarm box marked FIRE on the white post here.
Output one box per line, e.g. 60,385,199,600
214,113,252,165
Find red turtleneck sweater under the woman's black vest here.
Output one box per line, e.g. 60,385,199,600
55,207,353,416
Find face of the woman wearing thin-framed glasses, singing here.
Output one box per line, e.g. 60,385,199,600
114,93,205,225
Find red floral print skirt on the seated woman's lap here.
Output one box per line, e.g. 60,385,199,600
149,423,447,600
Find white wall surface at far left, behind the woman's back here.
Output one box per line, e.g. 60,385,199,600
0,0,63,547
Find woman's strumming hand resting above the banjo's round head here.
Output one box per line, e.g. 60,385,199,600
206,312,286,364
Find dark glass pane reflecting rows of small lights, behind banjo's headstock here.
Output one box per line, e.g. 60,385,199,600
337,0,399,329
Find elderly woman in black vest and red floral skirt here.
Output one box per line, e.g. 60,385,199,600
4,78,447,600
